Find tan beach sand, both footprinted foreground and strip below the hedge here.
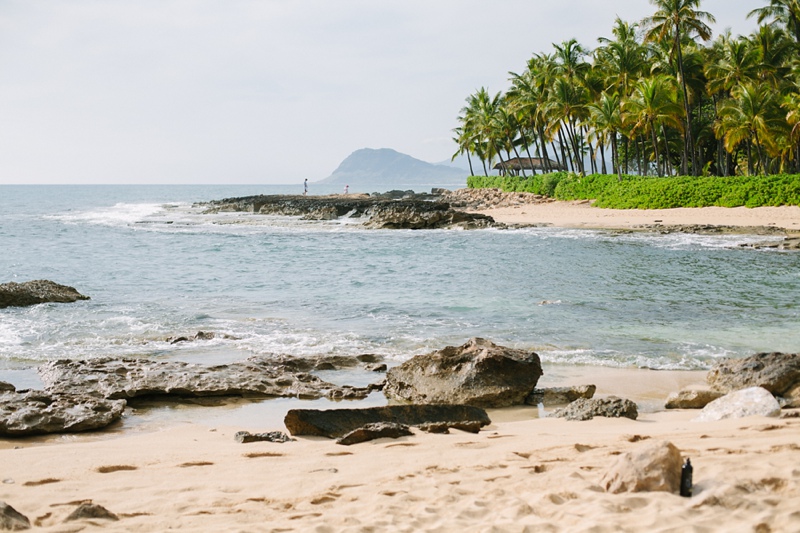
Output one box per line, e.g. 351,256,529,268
0,202,800,532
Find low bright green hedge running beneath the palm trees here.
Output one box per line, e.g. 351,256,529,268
467,172,800,209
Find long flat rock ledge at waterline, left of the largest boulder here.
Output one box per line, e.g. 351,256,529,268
34,357,374,399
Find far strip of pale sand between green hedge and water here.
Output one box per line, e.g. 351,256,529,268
472,201,800,233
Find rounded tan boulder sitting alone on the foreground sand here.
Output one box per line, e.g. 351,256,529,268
600,441,682,493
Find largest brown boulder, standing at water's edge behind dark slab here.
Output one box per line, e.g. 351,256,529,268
383,338,542,407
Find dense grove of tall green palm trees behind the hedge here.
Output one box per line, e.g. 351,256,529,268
453,0,800,179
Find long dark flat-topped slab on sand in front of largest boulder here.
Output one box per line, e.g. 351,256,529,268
283,405,491,438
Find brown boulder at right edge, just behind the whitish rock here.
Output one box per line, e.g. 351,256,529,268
706,352,800,398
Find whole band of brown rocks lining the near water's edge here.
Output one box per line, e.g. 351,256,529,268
0,338,800,443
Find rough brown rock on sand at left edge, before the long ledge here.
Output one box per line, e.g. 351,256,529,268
0,391,125,437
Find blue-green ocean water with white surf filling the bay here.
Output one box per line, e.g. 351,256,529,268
0,185,800,428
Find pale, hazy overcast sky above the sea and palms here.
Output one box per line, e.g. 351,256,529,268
0,0,768,184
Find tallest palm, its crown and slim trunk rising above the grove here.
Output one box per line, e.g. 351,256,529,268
644,0,715,175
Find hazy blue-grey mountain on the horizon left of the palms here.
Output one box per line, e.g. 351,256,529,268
319,148,469,191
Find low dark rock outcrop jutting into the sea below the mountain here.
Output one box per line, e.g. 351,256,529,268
199,191,496,229
